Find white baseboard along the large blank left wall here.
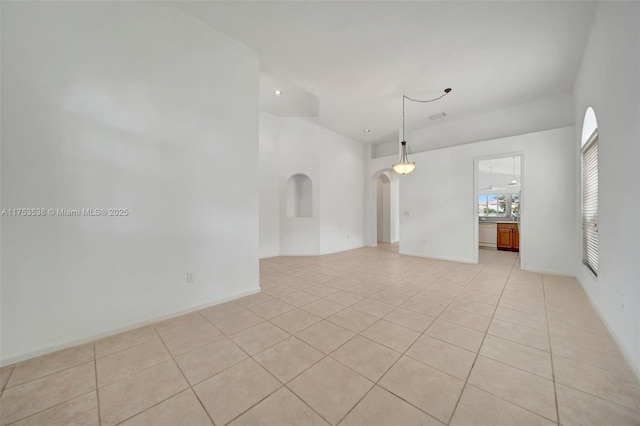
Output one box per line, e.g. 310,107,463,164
0,287,261,367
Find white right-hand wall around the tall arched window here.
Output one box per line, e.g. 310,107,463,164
573,2,640,372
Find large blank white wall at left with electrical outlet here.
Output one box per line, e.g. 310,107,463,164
1,2,258,363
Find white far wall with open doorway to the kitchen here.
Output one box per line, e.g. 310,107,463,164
368,126,576,275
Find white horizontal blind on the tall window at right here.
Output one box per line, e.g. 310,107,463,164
582,130,598,276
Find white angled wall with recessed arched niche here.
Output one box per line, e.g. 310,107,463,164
260,112,365,257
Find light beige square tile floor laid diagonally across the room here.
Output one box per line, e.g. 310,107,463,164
0,246,640,426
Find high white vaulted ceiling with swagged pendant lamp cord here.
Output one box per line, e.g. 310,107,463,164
174,1,594,143
